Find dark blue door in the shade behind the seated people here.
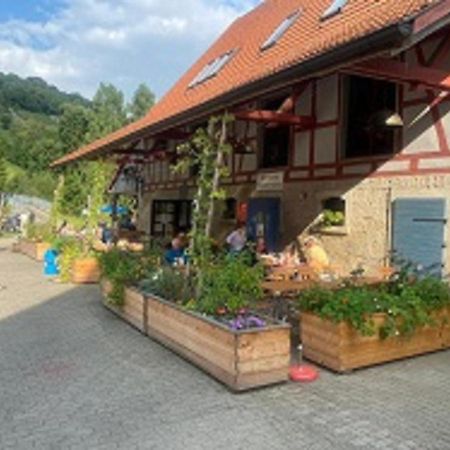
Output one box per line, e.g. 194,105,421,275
247,198,281,252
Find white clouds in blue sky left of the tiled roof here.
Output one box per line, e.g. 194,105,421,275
0,0,259,96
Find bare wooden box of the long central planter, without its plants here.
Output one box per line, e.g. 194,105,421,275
146,296,290,391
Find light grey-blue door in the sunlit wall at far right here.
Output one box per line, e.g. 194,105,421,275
392,198,447,276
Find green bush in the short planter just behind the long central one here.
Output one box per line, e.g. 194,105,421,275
98,249,149,306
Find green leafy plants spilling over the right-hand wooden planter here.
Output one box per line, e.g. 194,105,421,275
298,277,450,339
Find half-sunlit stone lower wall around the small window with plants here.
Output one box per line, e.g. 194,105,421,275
283,175,450,273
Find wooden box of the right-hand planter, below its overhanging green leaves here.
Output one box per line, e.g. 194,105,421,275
300,310,450,372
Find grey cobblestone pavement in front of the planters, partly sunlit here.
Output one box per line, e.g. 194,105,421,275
0,237,450,450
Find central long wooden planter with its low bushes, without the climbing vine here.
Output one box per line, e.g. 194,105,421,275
141,255,290,391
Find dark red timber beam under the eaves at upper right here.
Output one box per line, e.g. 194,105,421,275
349,58,450,92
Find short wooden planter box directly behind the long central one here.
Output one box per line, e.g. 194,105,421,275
101,280,146,333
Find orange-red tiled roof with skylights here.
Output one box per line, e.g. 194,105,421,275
54,0,440,165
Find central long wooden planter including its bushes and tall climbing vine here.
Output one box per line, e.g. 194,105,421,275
96,116,290,390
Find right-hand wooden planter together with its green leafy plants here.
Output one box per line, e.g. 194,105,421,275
299,277,450,372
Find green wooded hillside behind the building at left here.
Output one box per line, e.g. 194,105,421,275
0,73,155,200
